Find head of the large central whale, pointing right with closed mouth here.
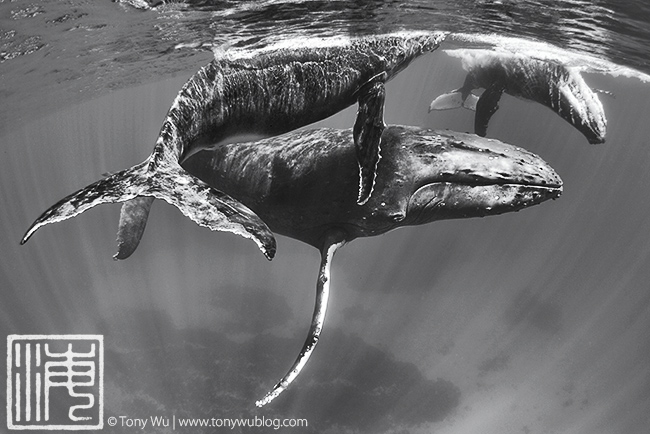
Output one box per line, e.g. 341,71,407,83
386,127,562,226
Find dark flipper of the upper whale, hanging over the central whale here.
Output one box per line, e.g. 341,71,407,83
353,73,386,205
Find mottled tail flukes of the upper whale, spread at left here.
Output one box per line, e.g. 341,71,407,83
20,159,276,259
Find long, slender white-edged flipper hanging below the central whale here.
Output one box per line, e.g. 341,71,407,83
255,230,345,407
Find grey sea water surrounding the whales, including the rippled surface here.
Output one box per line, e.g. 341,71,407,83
0,1,650,434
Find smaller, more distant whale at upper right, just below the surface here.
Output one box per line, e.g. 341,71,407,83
429,49,607,144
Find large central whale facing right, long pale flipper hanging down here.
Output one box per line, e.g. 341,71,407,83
180,126,562,407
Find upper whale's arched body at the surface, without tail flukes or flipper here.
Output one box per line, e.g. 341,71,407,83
159,32,445,160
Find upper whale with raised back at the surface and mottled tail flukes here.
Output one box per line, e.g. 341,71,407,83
21,32,446,259
